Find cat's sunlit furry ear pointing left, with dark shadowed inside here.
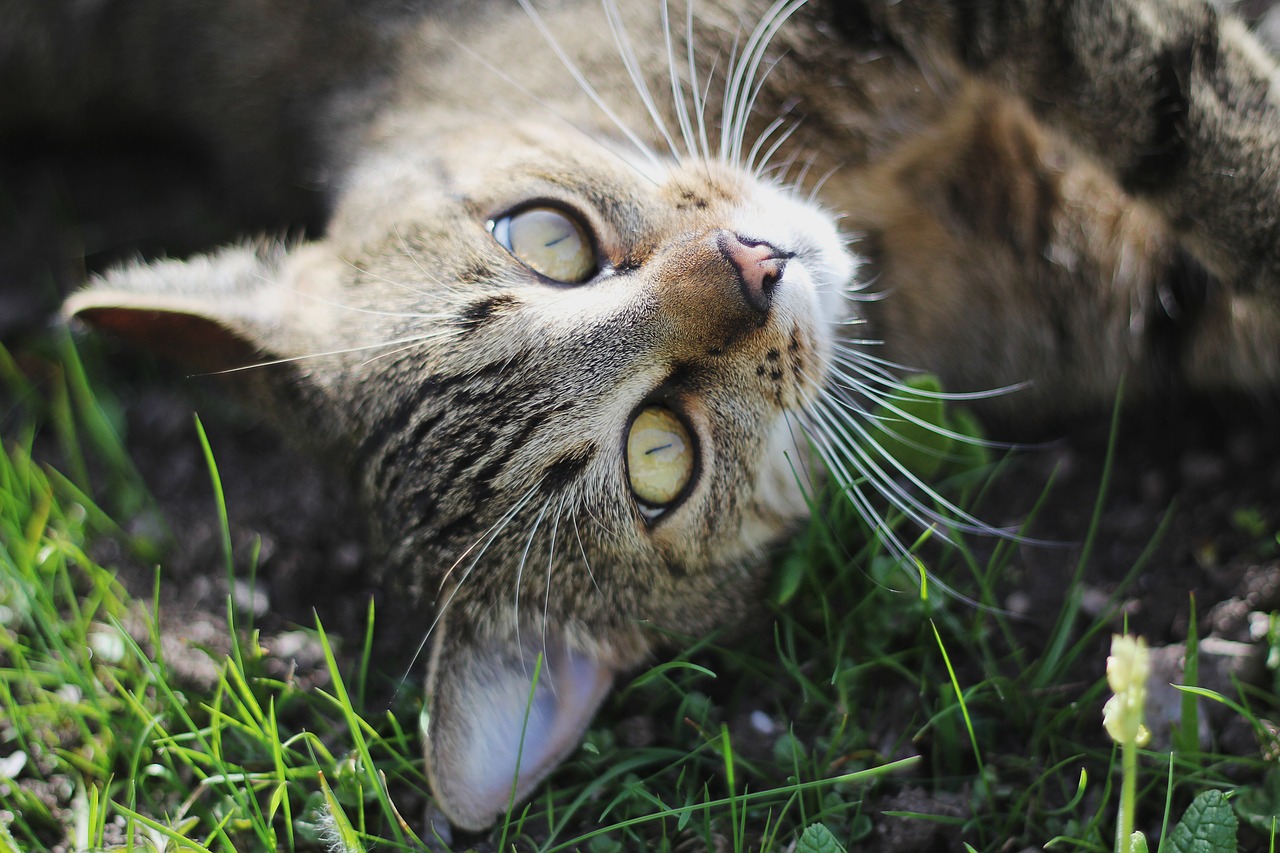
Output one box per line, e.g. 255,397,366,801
63,243,289,370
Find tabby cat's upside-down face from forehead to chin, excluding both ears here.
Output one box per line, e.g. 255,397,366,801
325,116,852,614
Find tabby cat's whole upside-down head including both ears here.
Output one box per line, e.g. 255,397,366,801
64,112,854,826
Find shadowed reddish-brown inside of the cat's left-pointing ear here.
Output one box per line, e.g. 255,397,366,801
76,306,259,370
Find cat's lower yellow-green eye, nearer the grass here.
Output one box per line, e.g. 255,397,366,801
627,406,694,517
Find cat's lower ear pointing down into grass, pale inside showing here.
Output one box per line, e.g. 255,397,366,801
425,616,613,830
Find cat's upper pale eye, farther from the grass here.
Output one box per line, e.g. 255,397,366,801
489,207,598,284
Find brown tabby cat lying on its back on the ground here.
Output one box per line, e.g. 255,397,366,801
0,0,1280,829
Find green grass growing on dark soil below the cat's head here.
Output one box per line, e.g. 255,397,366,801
0,342,1280,853
